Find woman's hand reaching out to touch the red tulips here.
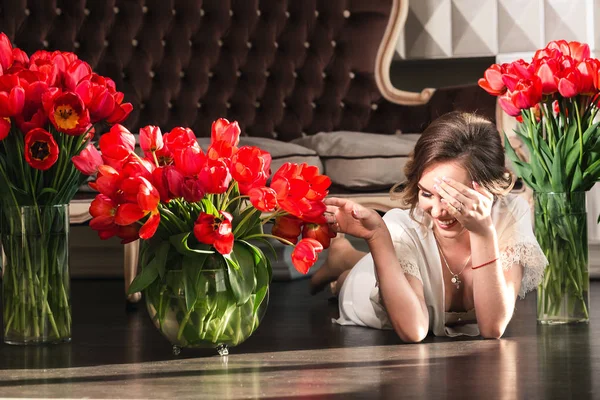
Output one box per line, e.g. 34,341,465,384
325,197,386,241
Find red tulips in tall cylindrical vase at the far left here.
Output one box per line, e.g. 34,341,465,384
0,33,132,343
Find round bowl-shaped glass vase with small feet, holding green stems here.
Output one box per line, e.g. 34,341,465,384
142,248,269,356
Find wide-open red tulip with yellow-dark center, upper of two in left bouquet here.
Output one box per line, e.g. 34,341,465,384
42,92,90,136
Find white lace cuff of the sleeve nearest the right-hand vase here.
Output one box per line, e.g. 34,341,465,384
500,242,548,298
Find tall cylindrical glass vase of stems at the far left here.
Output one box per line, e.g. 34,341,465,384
0,204,71,344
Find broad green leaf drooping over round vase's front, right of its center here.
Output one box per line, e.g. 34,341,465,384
224,242,256,305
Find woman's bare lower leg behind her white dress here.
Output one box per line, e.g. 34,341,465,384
310,234,366,294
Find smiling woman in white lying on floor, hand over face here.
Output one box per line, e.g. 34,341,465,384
311,112,547,342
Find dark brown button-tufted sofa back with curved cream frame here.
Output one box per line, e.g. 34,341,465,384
0,0,495,298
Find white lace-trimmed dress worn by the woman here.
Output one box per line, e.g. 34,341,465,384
334,194,548,336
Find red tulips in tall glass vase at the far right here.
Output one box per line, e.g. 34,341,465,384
479,40,600,323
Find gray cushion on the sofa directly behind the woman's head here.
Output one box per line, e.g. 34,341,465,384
293,131,420,190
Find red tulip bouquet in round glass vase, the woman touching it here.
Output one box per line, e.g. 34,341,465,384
89,119,332,346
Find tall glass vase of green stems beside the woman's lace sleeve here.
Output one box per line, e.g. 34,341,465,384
534,192,590,324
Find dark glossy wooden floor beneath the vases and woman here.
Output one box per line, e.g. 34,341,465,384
0,280,600,400
